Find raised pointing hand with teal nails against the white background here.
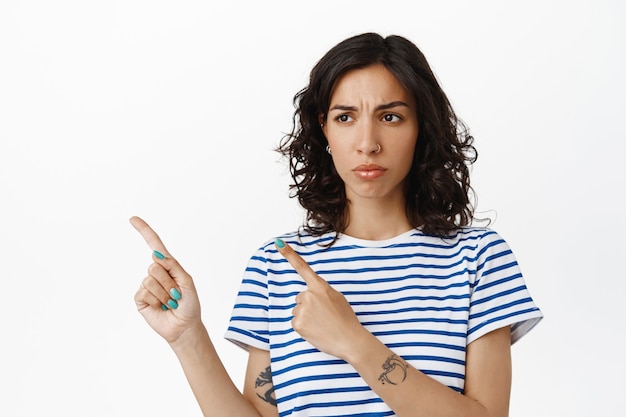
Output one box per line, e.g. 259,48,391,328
130,217,203,344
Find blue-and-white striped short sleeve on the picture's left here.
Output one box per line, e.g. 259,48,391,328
224,248,269,350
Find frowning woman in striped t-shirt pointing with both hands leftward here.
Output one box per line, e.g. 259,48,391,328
131,33,541,416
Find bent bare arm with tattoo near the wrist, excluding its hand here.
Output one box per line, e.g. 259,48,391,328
344,326,511,417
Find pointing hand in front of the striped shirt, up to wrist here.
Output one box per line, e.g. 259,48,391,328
276,241,370,360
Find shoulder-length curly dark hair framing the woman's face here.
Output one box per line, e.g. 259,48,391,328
277,33,478,239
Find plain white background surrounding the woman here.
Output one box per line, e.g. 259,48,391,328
0,0,626,417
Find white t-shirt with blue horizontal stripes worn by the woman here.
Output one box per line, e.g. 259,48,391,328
225,228,542,416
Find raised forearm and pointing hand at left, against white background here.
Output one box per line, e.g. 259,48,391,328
130,217,260,417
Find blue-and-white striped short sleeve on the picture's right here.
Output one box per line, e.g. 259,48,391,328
467,230,543,344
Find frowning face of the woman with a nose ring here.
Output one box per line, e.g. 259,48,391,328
323,64,419,204
